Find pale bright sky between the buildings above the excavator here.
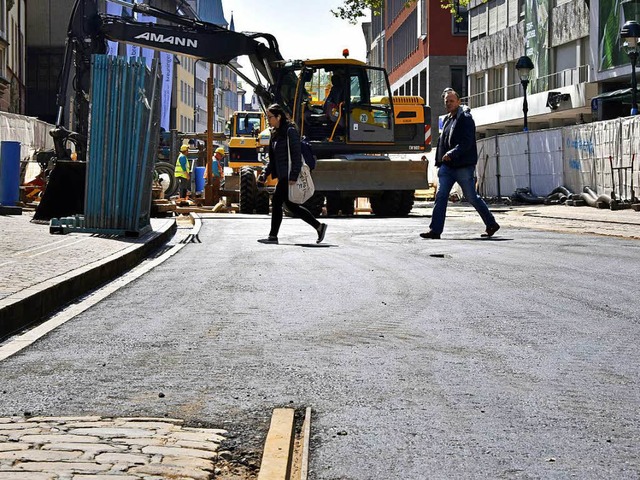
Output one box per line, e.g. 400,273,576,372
222,0,368,95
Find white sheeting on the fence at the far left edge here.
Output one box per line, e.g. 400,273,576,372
0,112,54,182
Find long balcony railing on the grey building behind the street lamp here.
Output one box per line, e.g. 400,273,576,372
462,65,590,108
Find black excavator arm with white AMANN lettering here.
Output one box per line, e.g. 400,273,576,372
51,0,284,160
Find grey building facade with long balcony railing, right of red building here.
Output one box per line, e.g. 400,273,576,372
466,0,598,136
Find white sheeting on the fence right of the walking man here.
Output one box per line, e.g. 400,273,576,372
477,117,640,200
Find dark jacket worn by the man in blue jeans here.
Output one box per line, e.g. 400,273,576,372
436,106,478,168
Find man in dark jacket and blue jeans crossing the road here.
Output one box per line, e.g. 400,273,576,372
420,88,500,239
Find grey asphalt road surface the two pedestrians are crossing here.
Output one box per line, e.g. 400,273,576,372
0,214,640,480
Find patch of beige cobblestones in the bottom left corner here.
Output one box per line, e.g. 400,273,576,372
0,416,228,480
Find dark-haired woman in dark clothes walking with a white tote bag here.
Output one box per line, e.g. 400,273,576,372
258,103,327,243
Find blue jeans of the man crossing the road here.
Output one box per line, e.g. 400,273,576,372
429,164,496,234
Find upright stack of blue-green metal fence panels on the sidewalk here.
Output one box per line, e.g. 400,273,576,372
71,55,162,235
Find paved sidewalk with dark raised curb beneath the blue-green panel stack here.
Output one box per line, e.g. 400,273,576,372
0,211,176,338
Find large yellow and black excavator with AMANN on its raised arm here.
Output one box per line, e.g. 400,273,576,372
45,0,431,216
